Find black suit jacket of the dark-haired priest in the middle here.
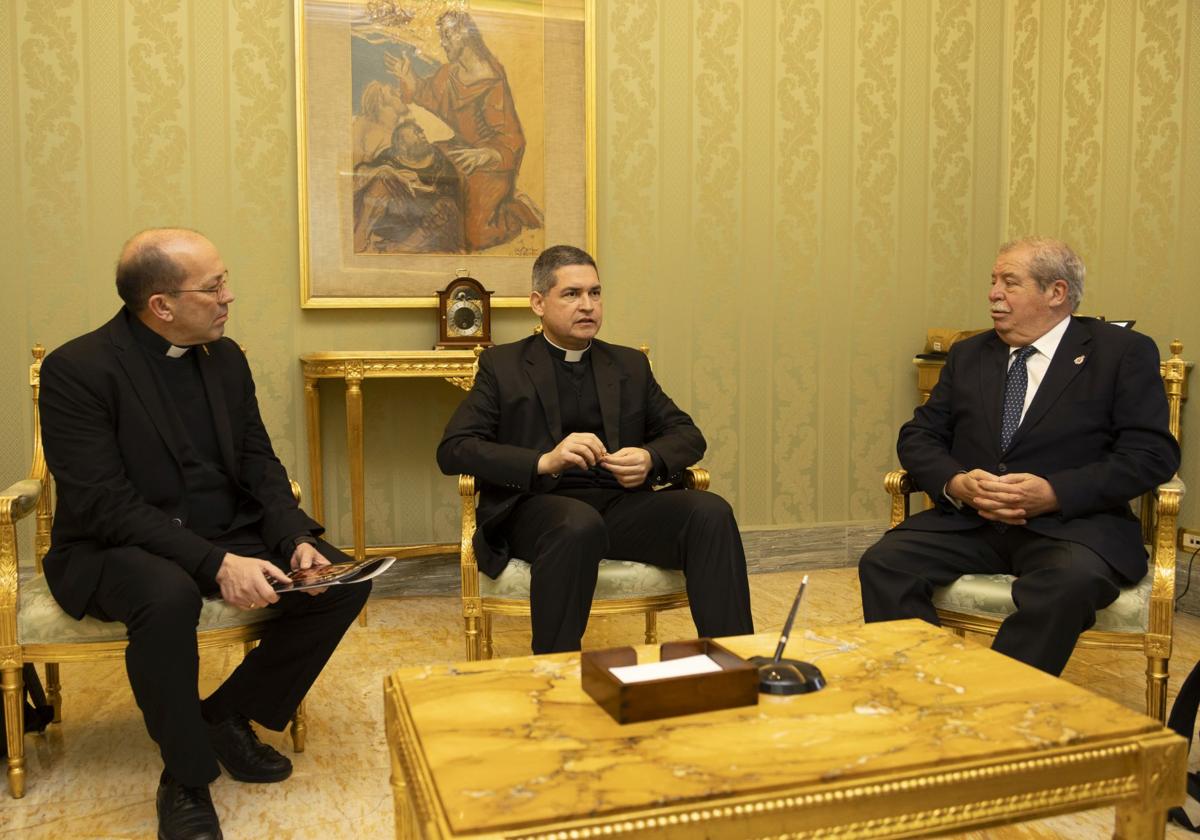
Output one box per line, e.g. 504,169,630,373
438,336,704,577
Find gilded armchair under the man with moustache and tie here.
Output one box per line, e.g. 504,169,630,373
883,341,1188,720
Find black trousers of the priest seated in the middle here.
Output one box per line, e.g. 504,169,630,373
504,488,754,653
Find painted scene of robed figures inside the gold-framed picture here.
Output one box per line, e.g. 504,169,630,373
352,10,545,256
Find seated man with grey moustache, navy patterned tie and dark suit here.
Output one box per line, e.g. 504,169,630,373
858,238,1180,674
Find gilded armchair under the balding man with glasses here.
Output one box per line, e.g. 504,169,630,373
0,344,307,798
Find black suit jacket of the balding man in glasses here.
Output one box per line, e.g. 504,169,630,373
38,310,323,618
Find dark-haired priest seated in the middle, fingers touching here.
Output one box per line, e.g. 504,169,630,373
438,245,754,653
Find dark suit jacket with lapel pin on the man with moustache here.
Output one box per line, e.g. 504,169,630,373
896,318,1180,581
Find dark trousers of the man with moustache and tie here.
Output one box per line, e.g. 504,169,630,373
858,524,1129,676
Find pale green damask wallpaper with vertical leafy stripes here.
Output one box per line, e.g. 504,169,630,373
0,0,1200,552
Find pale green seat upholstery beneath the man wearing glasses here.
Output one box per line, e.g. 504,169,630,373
17,575,276,644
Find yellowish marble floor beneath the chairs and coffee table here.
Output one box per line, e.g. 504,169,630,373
0,568,1200,840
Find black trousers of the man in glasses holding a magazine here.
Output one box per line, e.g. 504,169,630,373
88,540,371,787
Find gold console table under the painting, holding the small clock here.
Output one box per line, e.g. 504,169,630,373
300,348,479,560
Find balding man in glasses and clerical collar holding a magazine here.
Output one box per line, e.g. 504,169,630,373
40,229,370,838
